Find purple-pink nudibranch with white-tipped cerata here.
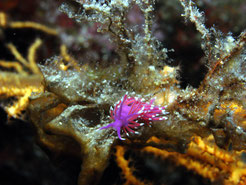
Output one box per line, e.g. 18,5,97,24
100,95,167,140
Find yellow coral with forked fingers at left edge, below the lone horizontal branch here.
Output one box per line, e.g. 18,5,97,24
0,39,43,117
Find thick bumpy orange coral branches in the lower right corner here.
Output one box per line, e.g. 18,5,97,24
142,135,246,185
